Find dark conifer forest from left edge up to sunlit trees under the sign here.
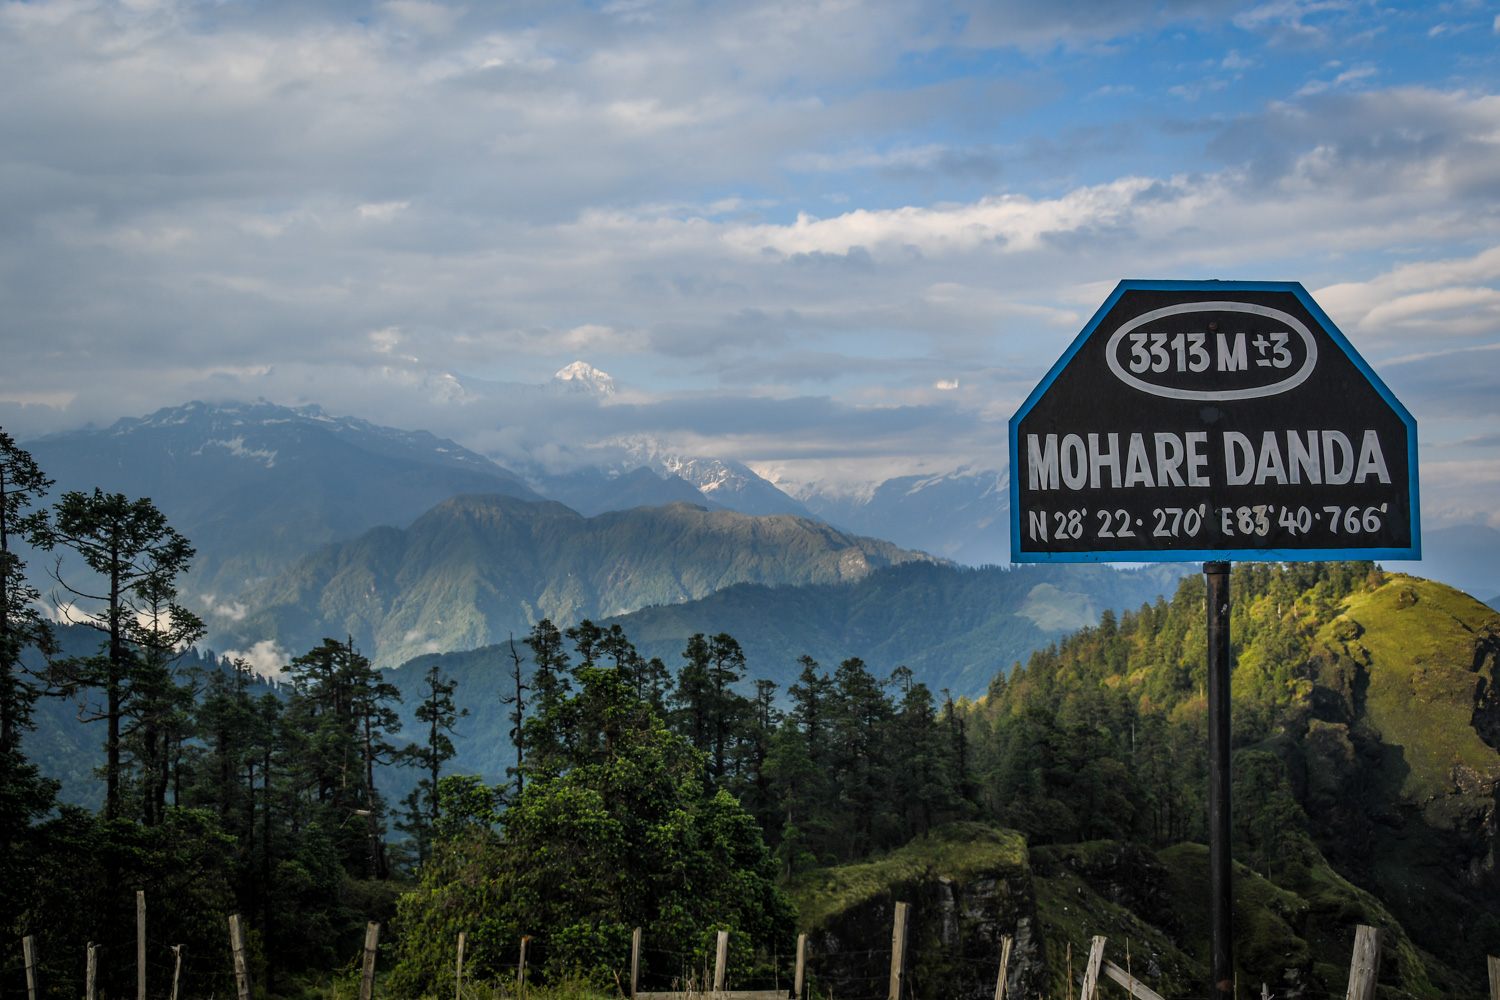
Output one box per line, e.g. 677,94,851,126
0,435,1488,997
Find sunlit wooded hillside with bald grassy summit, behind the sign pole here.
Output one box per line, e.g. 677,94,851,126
971,564,1500,996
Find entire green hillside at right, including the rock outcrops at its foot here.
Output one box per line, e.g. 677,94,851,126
792,564,1500,999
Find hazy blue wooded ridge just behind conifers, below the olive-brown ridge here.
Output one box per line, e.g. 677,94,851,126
392,561,1176,781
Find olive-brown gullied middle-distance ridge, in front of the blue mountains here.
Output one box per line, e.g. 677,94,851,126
220,495,932,666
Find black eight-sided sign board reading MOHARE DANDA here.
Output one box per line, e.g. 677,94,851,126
1010,280,1422,562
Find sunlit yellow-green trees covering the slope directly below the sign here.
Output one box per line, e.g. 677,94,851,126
972,562,1383,867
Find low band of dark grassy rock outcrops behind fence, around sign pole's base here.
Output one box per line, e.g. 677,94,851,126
791,823,1469,1000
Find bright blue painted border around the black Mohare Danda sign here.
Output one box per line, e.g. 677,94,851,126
1008,279,1422,562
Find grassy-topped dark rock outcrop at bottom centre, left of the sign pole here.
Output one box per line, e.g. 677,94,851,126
792,823,1047,1000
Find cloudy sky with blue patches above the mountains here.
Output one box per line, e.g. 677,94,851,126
0,0,1500,528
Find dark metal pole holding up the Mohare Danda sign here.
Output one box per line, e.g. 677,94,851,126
1203,562,1235,1000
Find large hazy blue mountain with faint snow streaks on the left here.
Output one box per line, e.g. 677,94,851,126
26,402,543,604
